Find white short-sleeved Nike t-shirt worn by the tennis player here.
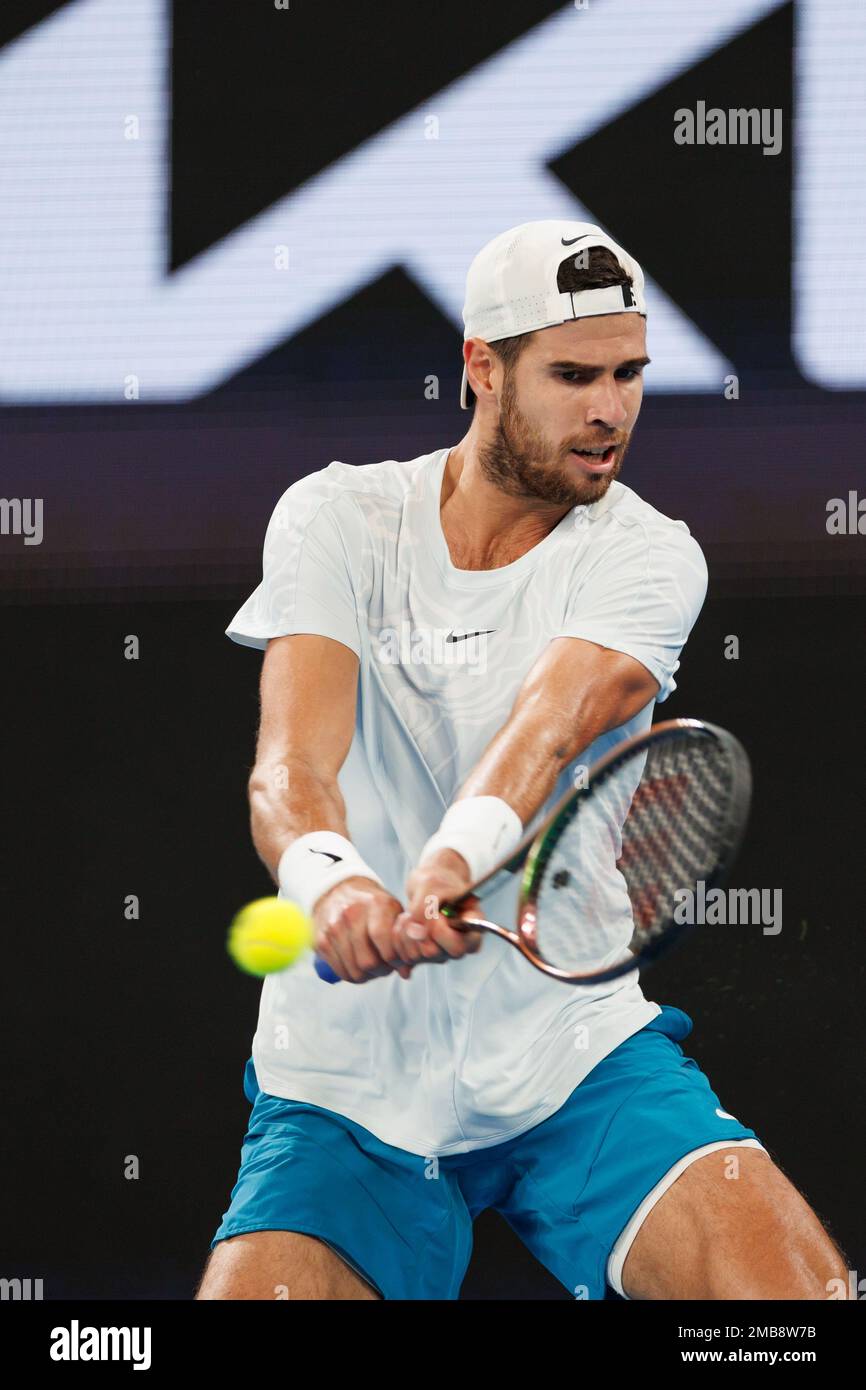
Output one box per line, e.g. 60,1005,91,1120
227,449,706,1155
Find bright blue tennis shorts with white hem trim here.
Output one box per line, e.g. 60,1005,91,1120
211,1005,763,1300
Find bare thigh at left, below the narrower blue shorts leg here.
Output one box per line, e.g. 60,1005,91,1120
196,1230,379,1300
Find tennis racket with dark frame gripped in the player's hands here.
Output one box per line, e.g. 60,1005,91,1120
316,719,752,984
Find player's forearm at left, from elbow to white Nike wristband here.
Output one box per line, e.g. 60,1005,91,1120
249,758,349,883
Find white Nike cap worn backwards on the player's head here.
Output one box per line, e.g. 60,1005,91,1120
460,221,646,410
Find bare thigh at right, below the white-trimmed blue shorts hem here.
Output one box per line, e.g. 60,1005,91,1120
621,1144,847,1300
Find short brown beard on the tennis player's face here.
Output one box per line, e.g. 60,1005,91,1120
478,374,630,507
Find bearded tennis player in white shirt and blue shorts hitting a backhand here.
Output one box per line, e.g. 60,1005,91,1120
196,221,847,1300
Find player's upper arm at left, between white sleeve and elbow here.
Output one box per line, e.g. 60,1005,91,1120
256,632,360,777
